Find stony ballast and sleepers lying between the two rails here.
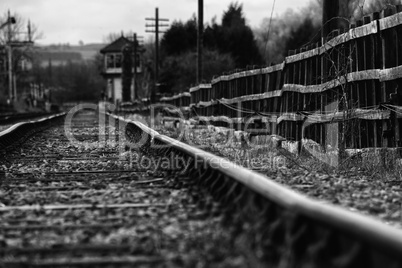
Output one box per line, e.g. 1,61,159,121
0,109,254,267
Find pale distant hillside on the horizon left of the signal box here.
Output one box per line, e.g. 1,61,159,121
34,44,105,66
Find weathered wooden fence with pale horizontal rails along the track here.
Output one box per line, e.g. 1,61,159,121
158,6,402,151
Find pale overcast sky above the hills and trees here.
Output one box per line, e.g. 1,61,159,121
0,0,309,44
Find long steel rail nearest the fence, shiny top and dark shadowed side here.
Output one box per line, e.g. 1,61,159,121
109,112,402,267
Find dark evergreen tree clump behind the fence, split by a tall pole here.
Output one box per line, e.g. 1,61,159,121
160,3,263,93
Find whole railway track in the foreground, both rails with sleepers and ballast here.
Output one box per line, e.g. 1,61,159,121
0,108,402,267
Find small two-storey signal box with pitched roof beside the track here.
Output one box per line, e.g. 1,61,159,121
100,36,141,105
